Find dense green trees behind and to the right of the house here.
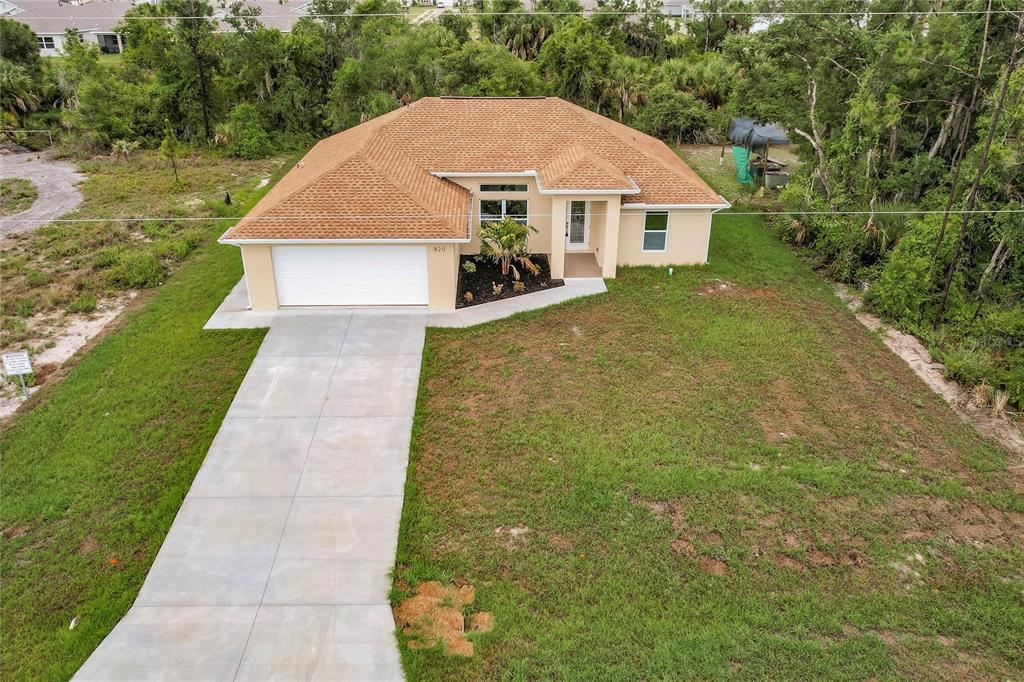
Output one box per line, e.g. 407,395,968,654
0,0,1024,406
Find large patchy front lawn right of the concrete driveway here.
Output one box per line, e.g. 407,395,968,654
395,214,1024,680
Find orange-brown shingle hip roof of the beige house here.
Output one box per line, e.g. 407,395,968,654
223,97,722,241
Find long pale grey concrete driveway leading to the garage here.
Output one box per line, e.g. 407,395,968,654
76,311,426,680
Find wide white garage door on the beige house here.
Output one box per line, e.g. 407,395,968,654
273,244,427,305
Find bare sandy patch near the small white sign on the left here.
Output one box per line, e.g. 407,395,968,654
0,292,136,419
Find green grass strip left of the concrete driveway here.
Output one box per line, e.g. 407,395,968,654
0,166,280,680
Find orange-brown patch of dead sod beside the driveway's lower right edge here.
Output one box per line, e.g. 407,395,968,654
392,581,494,656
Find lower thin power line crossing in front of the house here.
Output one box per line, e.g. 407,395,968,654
0,208,1024,223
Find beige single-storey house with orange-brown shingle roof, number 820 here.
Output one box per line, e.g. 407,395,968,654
220,97,729,309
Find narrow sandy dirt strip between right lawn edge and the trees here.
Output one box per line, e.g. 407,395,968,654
836,285,1024,456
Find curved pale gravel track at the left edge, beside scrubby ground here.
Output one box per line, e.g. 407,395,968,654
0,152,85,237
